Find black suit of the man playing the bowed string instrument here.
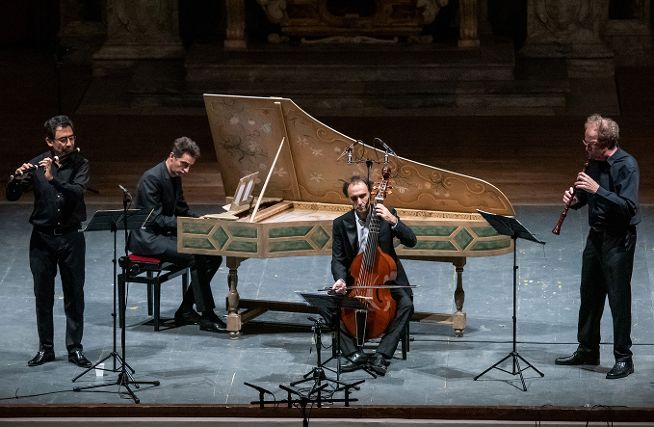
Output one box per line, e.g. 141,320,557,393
328,209,417,358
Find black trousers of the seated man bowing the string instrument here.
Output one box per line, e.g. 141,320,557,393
321,288,413,359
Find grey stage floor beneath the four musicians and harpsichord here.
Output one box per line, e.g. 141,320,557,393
0,203,654,408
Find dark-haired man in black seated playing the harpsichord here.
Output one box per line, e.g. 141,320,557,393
128,136,225,332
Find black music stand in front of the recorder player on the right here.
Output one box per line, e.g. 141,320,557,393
474,209,545,391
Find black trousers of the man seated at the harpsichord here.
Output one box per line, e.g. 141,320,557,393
147,236,223,312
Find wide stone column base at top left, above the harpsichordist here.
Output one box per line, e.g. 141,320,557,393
93,0,184,75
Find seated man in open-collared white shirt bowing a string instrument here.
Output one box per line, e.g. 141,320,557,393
326,176,417,376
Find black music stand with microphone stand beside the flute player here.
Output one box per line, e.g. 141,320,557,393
73,206,159,403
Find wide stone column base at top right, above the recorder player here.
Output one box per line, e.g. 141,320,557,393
520,0,614,78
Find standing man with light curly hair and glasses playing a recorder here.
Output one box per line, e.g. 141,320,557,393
556,114,640,379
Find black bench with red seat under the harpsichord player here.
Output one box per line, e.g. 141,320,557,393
118,254,189,331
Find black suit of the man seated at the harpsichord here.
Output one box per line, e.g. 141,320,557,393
128,161,222,312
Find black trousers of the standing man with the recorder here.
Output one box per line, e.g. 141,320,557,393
577,227,636,361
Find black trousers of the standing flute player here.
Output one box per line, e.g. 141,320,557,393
29,229,86,353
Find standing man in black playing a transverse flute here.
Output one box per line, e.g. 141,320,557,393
6,116,91,368
